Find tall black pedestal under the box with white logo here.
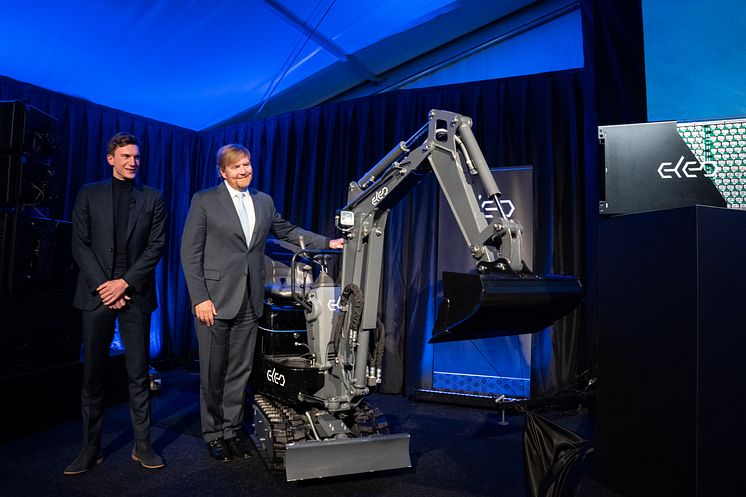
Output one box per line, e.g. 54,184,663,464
596,206,746,497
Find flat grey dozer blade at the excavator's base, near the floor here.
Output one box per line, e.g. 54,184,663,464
285,433,412,481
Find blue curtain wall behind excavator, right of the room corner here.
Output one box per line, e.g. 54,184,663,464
195,71,585,396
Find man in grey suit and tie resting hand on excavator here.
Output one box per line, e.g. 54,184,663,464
181,144,343,462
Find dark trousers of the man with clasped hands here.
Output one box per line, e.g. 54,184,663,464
81,303,150,447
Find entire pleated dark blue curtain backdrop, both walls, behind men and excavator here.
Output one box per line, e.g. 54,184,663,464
0,70,587,396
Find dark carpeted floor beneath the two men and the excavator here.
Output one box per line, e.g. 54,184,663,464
0,370,612,497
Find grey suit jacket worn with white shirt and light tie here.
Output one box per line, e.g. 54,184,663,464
181,183,329,319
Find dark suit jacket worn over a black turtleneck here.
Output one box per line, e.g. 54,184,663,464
72,179,166,312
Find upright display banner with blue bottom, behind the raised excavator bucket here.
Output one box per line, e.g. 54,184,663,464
433,166,534,398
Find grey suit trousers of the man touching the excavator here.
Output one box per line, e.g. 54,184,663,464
195,294,258,442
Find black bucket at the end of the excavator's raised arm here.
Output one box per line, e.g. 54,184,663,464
430,272,583,343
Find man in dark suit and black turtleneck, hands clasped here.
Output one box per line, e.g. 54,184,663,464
64,133,166,475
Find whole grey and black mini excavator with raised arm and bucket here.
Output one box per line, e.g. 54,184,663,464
252,110,582,481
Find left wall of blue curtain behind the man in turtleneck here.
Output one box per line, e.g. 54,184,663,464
0,77,197,357
